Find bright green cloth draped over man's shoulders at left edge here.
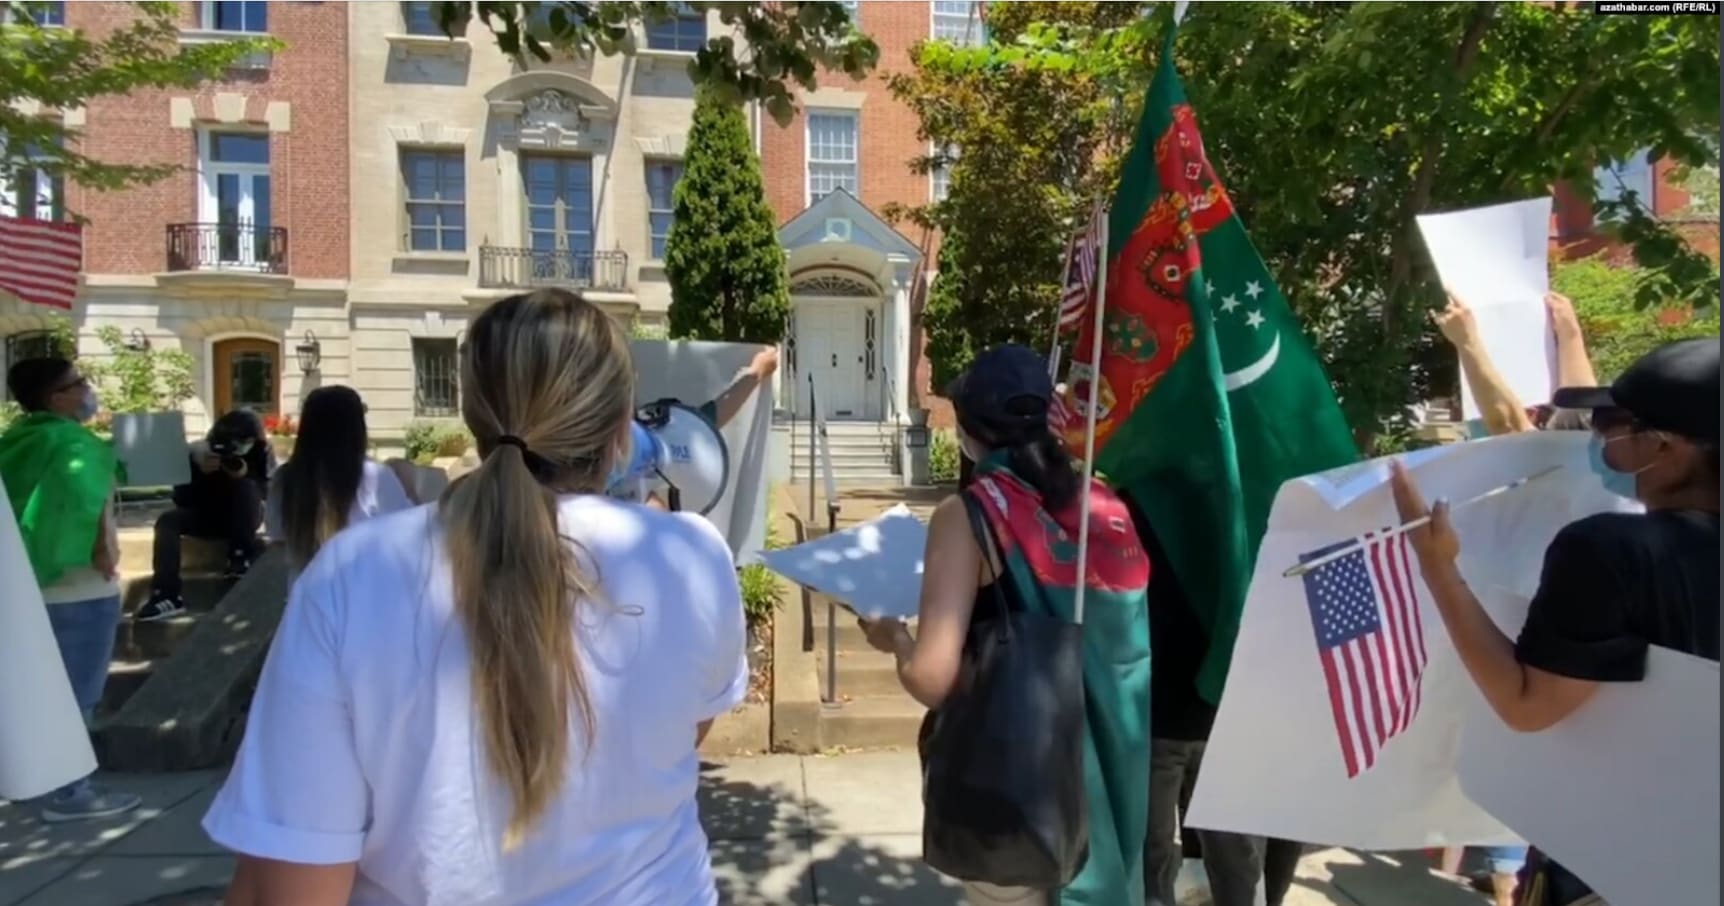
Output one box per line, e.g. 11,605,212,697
0,412,117,587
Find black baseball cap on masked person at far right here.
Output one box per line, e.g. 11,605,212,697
1550,338,1719,444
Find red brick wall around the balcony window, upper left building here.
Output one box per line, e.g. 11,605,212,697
66,2,350,279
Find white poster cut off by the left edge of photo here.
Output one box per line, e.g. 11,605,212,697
0,471,97,799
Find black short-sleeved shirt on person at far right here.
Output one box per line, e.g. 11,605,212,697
1515,510,1719,682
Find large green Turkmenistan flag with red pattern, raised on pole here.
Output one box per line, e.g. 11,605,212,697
1064,24,1357,701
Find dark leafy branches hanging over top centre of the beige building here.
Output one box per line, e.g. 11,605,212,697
436,0,879,126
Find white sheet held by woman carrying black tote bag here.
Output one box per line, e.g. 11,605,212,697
760,503,928,620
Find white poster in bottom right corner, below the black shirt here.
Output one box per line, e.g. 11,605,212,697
1460,647,1721,906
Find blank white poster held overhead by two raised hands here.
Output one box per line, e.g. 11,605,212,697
1419,196,1557,420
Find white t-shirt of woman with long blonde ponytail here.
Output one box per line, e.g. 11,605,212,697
203,496,748,906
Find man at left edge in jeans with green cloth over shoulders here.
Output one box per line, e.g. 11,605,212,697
0,358,140,823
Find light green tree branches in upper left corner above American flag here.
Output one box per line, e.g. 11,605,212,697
0,0,278,203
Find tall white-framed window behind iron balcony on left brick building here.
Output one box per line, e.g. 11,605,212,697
197,131,271,267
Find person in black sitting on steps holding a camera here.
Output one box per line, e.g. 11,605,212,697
134,408,276,624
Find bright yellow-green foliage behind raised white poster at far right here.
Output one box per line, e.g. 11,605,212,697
1550,258,1719,382
